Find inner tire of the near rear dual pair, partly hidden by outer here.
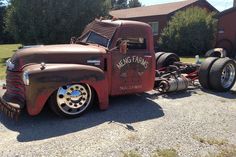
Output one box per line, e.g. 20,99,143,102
198,57,218,89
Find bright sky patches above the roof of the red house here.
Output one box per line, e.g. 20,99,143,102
139,0,233,11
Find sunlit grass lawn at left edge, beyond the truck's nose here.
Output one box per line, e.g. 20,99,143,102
0,44,21,79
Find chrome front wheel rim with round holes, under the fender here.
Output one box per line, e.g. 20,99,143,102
57,84,91,115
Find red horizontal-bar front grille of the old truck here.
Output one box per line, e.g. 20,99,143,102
6,71,25,102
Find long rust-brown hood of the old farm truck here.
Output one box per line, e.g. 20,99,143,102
10,44,106,71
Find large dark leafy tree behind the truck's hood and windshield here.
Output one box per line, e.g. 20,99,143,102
5,0,111,44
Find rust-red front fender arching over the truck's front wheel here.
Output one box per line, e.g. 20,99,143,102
23,64,108,115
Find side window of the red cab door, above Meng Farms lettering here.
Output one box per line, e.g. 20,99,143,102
116,38,147,50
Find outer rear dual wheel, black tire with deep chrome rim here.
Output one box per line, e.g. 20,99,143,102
209,58,236,92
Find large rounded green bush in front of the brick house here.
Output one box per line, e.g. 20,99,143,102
160,7,217,56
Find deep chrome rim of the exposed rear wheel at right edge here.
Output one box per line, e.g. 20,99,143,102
221,64,235,88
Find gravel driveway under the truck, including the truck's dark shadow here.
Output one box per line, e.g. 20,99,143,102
0,79,236,157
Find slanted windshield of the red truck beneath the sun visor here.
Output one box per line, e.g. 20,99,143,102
80,31,109,47
